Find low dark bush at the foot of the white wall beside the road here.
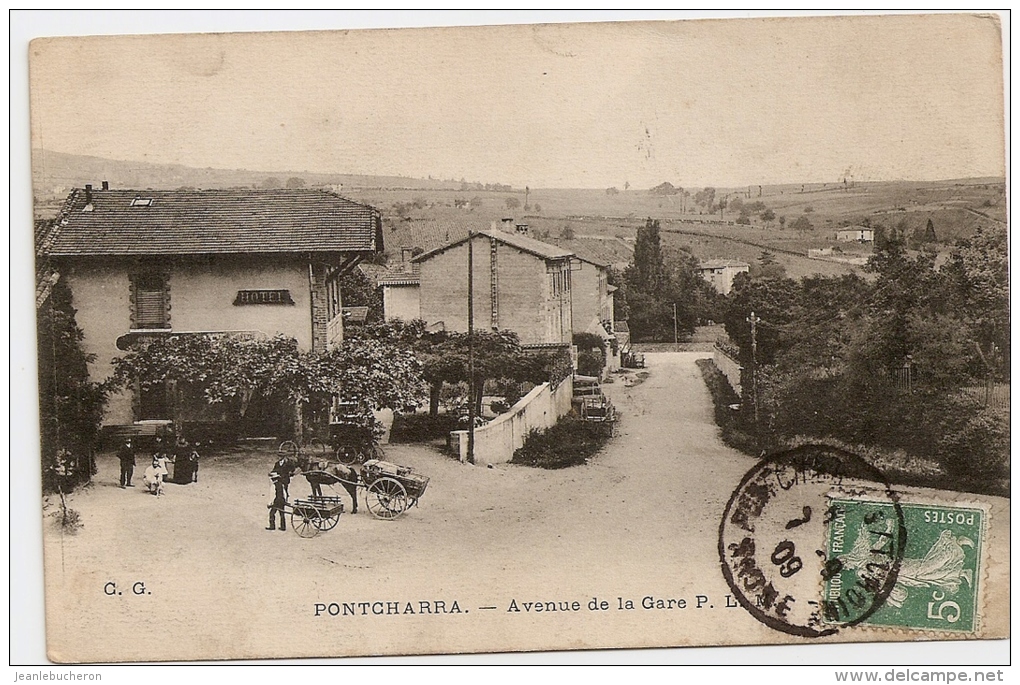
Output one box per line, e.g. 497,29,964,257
510,414,613,469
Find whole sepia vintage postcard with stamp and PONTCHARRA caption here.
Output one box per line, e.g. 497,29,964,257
19,13,1011,664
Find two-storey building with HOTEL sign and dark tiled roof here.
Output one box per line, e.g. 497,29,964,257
39,182,383,425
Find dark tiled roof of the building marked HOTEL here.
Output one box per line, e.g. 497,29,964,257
41,190,383,256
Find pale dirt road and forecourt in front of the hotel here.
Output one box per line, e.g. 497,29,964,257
46,353,1008,661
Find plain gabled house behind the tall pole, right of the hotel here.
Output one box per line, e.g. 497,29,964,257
412,220,573,346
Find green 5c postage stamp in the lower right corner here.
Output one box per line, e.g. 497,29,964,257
822,498,987,633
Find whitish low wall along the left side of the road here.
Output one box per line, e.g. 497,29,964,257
450,376,573,464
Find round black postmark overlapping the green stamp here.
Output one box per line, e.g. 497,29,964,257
719,444,907,637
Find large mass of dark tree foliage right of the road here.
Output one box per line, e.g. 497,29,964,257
725,227,1009,491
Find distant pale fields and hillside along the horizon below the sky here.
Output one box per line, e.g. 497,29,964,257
33,153,1006,277
